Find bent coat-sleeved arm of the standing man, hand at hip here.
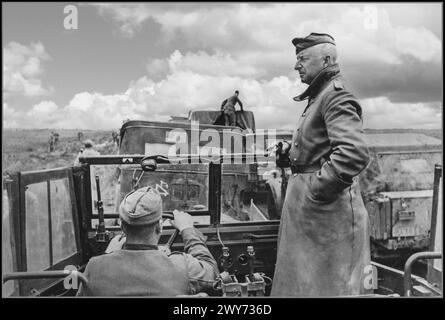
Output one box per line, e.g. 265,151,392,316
313,90,370,197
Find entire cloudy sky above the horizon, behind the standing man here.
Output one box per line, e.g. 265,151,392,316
2,3,442,129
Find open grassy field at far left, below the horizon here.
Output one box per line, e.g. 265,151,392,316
2,129,118,175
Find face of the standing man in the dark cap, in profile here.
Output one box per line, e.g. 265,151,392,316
295,47,326,84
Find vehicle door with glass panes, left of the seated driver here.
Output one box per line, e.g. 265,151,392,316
2,168,82,296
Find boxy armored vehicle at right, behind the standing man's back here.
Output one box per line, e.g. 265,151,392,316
360,133,442,257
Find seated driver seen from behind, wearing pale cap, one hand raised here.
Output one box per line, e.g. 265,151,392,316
78,187,219,296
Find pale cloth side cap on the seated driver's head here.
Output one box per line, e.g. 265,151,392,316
119,187,162,226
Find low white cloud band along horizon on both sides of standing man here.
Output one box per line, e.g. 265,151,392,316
3,62,442,129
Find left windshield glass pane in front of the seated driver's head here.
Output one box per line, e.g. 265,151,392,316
90,164,210,225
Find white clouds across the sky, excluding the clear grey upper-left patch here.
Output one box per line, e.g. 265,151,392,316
4,3,442,129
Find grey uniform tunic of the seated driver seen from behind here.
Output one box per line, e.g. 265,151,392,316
78,228,218,297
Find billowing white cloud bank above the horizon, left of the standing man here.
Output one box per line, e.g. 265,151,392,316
3,51,303,129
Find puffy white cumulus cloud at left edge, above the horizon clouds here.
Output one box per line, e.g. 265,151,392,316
3,42,54,98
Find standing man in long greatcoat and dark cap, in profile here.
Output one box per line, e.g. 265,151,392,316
271,33,370,297
